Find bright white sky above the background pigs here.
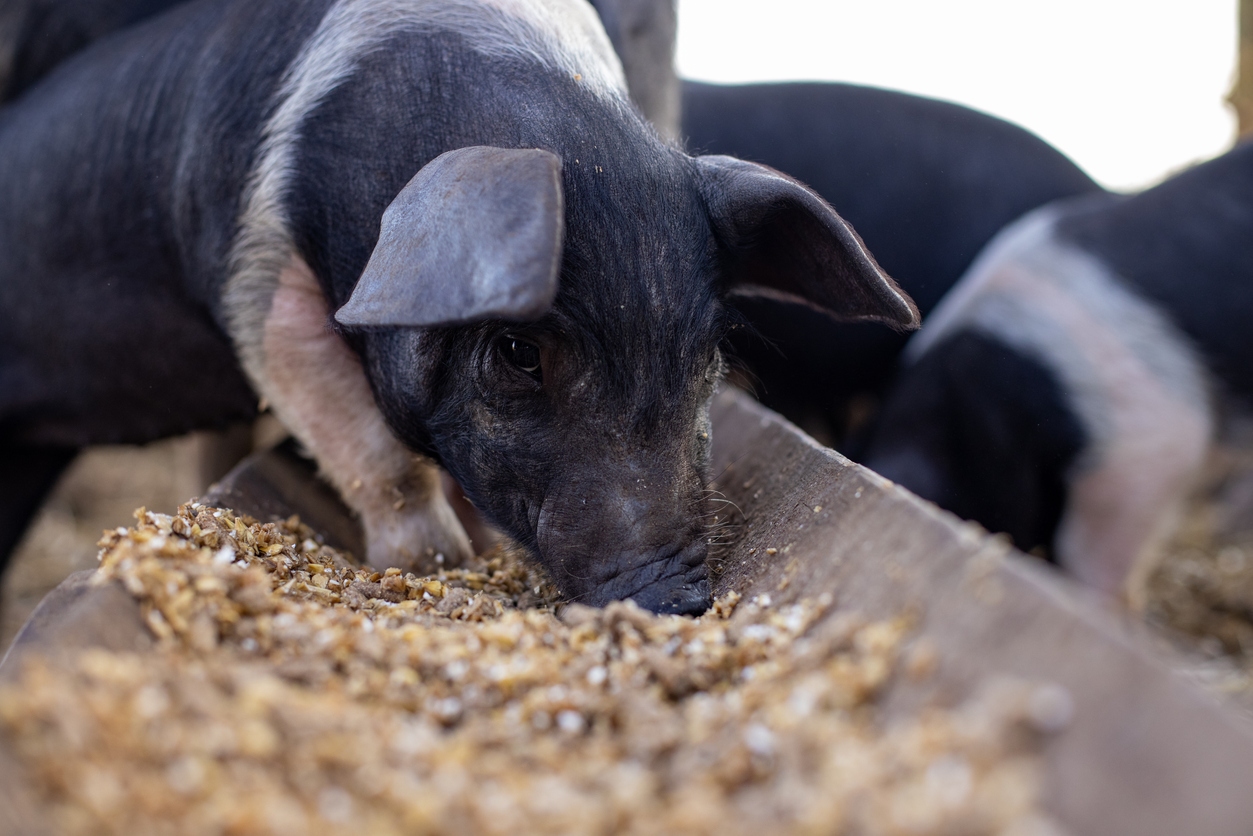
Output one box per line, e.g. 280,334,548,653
678,0,1237,189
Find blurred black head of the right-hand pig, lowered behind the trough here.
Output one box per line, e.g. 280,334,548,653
862,330,1088,559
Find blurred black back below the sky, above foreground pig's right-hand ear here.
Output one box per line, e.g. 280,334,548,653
683,81,1099,315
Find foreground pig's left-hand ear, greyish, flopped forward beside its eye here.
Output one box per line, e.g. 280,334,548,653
335,147,564,327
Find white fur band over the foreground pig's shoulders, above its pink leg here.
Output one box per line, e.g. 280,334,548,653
223,0,627,392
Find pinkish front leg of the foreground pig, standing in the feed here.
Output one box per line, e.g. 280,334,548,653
261,258,471,569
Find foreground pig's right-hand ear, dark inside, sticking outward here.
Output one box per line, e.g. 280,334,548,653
697,157,920,330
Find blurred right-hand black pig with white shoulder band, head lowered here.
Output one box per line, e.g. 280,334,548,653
866,144,1253,594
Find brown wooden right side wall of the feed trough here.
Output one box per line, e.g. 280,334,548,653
713,394,1253,836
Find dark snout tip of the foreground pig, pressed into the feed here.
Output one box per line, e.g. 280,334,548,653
580,540,712,615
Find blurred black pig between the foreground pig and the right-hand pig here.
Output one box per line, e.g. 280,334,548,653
682,81,1100,448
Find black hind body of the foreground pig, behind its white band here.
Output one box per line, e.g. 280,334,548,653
0,0,320,446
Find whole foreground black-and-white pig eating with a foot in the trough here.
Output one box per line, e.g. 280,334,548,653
0,0,917,613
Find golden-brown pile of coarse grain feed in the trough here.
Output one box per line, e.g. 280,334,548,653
0,505,1064,836
